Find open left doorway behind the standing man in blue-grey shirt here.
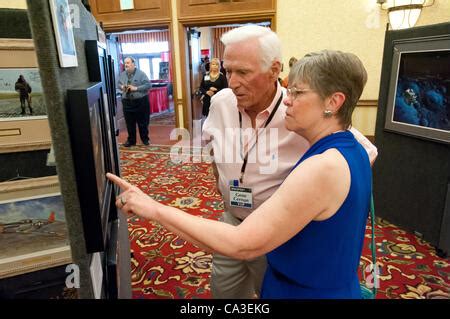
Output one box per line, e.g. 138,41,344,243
107,27,176,144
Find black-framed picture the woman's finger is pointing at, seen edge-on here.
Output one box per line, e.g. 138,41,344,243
67,82,115,253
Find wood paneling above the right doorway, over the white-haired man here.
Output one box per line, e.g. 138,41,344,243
177,0,276,21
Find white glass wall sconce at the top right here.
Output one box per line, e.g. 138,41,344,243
377,0,435,30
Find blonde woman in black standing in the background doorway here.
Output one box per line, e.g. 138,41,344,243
200,58,228,117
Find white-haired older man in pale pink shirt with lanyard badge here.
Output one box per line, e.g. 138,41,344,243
203,25,377,299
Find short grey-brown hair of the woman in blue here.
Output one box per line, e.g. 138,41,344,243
289,50,367,127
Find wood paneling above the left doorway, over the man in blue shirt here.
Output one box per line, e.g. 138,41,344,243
89,0,171,31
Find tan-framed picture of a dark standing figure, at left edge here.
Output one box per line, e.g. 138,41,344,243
0,38,51,153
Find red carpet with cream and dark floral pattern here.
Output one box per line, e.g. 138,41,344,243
121,145,450,299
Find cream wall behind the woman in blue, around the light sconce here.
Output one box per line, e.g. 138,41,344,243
277,0,450,135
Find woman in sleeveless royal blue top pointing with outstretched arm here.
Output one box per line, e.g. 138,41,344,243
108,50,372,299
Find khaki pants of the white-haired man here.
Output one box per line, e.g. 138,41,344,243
211,212,267,299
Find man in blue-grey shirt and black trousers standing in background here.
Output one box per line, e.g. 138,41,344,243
118,57,152,147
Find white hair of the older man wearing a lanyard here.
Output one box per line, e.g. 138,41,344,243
220,24,282,71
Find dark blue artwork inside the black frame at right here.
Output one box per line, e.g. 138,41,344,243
393,51,450,131
